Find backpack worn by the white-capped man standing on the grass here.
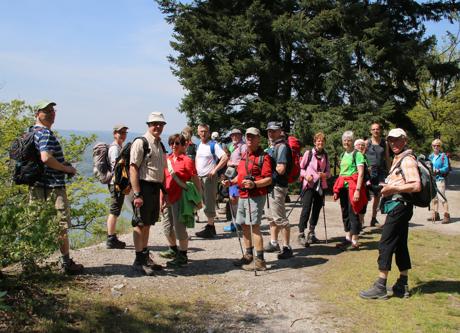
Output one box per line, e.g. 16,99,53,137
390,153,438,207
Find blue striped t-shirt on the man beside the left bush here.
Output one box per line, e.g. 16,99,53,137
33,125,66,187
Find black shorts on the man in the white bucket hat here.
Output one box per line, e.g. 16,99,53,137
132,180,162,226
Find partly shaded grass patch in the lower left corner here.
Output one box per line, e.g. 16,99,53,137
0,270,223,333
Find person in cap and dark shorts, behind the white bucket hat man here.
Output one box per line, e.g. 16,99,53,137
106,124,128,249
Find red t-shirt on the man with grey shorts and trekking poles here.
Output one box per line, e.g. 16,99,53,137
238,149,272,198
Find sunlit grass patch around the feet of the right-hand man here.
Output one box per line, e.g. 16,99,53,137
318,230,460,332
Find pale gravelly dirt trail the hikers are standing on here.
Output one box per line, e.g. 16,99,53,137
73,164,460,332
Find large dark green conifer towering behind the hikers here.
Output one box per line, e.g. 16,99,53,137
157,0,460,148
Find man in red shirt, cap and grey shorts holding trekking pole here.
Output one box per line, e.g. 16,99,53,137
223,127,272,271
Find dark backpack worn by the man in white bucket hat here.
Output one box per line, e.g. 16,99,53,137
113,136,166,194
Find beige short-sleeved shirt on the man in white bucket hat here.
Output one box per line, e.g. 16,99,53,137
130,131,166,183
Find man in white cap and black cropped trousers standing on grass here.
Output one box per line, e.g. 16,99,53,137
360,128,421,299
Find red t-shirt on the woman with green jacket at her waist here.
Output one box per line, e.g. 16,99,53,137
165,154,197,204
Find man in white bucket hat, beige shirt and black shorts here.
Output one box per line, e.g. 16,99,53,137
129,112,166,275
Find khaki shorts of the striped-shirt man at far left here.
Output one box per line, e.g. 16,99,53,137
29,186,70,230
